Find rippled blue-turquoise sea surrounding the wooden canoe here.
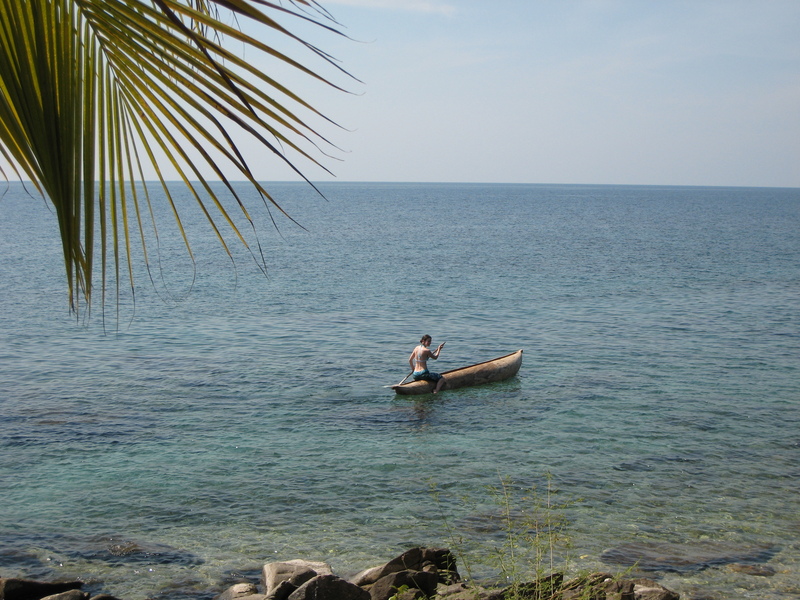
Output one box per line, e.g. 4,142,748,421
0,184,800,600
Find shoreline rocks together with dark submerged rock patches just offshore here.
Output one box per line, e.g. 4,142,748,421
0,540,778,600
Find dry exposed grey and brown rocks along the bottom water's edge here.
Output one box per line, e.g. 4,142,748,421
0,548,680,600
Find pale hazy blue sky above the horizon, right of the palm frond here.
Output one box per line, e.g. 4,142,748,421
278,0,800,187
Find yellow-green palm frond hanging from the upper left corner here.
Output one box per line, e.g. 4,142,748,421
0,0,350,311
